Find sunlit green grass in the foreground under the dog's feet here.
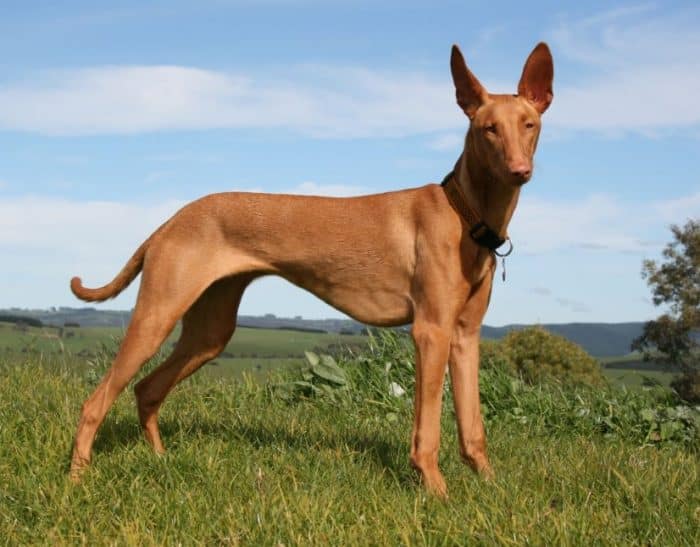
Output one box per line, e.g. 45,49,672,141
0,346,700,545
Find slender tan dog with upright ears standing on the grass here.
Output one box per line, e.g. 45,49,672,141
71,43,553,495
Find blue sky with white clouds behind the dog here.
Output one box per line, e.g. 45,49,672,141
0,0,700,325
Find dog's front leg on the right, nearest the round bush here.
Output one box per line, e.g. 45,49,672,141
449,278,493,477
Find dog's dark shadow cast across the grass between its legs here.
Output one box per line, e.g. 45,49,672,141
94,418,418,488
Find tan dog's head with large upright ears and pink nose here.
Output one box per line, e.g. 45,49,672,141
450,42,554,186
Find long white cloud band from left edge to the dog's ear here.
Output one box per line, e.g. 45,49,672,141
0,65,454,137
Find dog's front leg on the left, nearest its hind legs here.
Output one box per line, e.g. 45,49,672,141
411,321,449,497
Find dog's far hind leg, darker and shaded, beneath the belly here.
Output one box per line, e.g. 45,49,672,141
134,276,250,453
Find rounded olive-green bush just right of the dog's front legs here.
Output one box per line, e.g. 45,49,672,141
502,327,605,386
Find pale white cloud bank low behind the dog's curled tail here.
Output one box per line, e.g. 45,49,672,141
0,196,182,307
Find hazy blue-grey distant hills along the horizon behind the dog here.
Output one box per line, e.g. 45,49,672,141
0,307,644,357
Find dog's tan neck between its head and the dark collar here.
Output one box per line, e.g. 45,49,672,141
454,131,520,238
